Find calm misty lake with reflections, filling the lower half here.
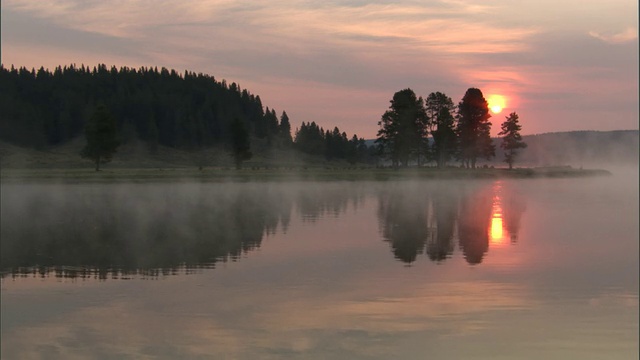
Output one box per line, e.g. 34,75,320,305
1,169,639,359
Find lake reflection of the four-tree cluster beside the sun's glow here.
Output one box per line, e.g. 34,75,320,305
378,183,525,264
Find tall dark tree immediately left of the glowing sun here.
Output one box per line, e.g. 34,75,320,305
456,88,495,169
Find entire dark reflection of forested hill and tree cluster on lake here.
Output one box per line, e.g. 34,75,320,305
1,182,524,279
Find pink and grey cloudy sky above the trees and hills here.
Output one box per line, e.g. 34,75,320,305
0,0,638,139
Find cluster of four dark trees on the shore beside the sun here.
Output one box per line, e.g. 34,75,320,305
376,88,526,168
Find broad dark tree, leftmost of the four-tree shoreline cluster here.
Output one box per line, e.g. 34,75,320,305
376,89,428,167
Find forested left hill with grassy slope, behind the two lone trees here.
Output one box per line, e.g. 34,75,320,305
0,64,370,165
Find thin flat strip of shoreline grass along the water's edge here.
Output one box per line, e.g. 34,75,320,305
0,167,611,183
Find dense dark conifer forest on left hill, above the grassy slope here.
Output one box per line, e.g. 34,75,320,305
0,64,364,167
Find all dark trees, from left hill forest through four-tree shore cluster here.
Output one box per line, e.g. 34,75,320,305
0,64,526,170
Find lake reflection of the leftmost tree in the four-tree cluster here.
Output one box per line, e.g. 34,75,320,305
378,188,428,263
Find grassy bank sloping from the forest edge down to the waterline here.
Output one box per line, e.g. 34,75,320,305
0,138,610,182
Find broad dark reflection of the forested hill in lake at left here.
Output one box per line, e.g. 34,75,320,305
0,184,292,278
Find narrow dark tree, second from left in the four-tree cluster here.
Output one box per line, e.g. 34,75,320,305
425,92,456,168
